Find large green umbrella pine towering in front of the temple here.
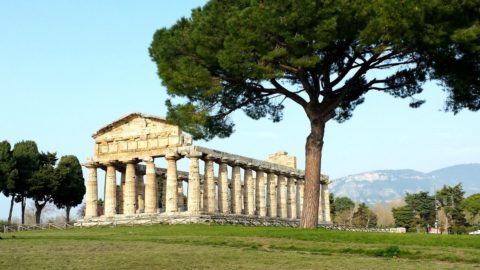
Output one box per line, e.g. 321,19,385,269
149,0,480,227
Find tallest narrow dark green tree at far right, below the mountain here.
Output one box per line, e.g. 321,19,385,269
437,184,466,233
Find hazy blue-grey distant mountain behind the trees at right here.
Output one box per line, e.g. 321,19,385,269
330,163,480,204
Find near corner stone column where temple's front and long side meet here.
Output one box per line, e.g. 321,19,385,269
187,152,202,214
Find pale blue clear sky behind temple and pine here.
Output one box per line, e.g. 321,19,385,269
0,0,480,219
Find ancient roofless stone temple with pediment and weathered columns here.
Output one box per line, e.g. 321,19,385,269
77,113,330,226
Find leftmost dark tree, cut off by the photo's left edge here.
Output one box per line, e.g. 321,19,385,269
0,141,18,223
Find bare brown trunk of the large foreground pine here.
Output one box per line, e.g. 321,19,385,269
300,119,326,228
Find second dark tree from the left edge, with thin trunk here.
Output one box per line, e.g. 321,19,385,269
12,141,40,224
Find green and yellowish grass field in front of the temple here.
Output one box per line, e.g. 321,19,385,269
0,225,480,270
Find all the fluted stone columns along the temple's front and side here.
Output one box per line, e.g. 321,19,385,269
85,152,330,222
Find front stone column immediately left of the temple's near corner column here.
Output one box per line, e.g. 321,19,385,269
165,154,178,213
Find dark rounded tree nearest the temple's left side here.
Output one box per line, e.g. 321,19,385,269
54,155,85,222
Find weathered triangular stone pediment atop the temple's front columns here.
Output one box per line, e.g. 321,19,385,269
92,113,191,157
